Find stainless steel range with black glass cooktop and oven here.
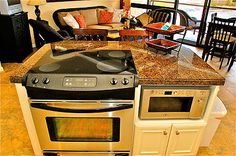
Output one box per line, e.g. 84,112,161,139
23,50,138,156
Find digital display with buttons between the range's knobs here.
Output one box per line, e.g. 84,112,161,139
63,76,97,87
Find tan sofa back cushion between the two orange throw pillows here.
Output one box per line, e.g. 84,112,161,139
80,9,98,25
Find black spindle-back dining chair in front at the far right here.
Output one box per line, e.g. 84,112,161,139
202,22,236,69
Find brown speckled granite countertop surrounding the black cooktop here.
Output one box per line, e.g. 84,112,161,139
10,41,225,86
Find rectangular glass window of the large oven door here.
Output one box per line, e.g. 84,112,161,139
46,117,120,142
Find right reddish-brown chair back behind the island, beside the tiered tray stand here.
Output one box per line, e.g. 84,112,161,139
119,29,154,42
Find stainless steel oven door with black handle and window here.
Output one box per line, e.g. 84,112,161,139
31,101,134,151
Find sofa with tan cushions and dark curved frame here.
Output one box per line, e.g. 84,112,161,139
53,6,123,36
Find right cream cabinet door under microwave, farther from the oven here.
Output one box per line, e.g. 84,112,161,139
166,123,206,156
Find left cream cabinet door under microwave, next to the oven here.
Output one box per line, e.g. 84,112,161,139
133,124,171,156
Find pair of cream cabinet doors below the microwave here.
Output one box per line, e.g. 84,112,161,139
133,123,205,156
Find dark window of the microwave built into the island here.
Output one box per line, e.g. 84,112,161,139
148,97,193,112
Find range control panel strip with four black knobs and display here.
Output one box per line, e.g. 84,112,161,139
25,74,138,91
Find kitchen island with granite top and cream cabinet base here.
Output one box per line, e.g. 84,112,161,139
10,41,224,156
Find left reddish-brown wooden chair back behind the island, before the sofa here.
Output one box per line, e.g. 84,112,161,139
73,28,108,41
